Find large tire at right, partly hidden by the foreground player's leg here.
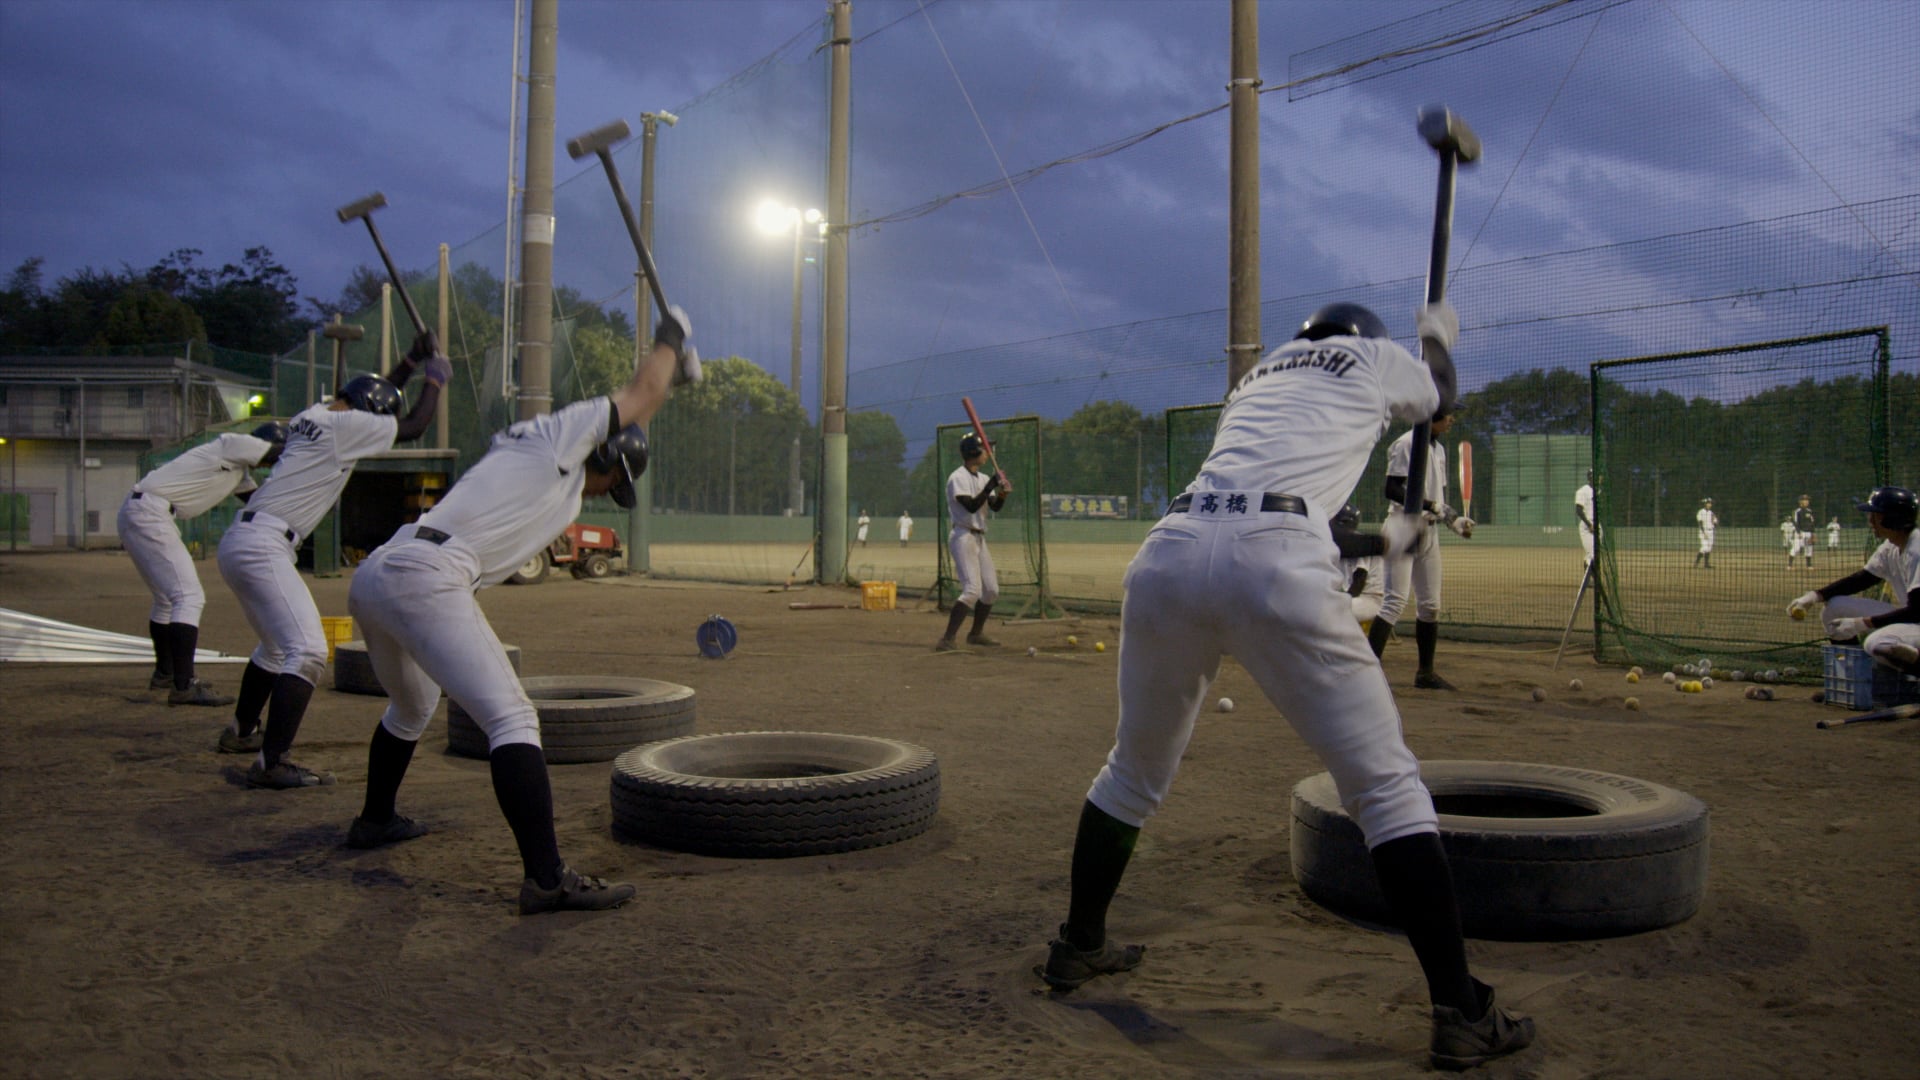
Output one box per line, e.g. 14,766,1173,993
1292,761,1709,942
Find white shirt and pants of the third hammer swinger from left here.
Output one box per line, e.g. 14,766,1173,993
348,398,614,749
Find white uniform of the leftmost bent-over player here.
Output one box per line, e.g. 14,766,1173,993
117,432,273,626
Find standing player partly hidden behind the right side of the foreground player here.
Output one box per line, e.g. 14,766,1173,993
1367,402,1473,690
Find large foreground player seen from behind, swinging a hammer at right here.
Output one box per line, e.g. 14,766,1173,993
1039,304,1534,1068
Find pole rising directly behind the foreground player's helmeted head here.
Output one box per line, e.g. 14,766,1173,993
1227,0,1261,390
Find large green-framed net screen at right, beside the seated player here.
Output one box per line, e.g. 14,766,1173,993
1592,327,1910,678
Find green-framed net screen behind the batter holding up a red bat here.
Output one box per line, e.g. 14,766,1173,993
925,417,1060,619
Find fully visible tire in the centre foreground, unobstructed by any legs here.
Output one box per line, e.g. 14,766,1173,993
612,732,941,859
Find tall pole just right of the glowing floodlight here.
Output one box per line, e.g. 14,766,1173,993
814,0,852,584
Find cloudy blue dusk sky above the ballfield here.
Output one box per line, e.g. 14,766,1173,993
0,0,1920,428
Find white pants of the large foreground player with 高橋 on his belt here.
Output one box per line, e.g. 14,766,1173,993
1087,492,1440,847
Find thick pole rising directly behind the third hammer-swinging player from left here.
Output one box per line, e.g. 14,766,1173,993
518,0,561,421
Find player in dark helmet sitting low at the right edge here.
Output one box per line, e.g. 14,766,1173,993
1788,486,1920,675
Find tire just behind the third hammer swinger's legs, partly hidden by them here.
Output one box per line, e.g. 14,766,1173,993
447,675,693,765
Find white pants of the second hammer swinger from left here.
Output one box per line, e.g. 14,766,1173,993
216,500,326,686
